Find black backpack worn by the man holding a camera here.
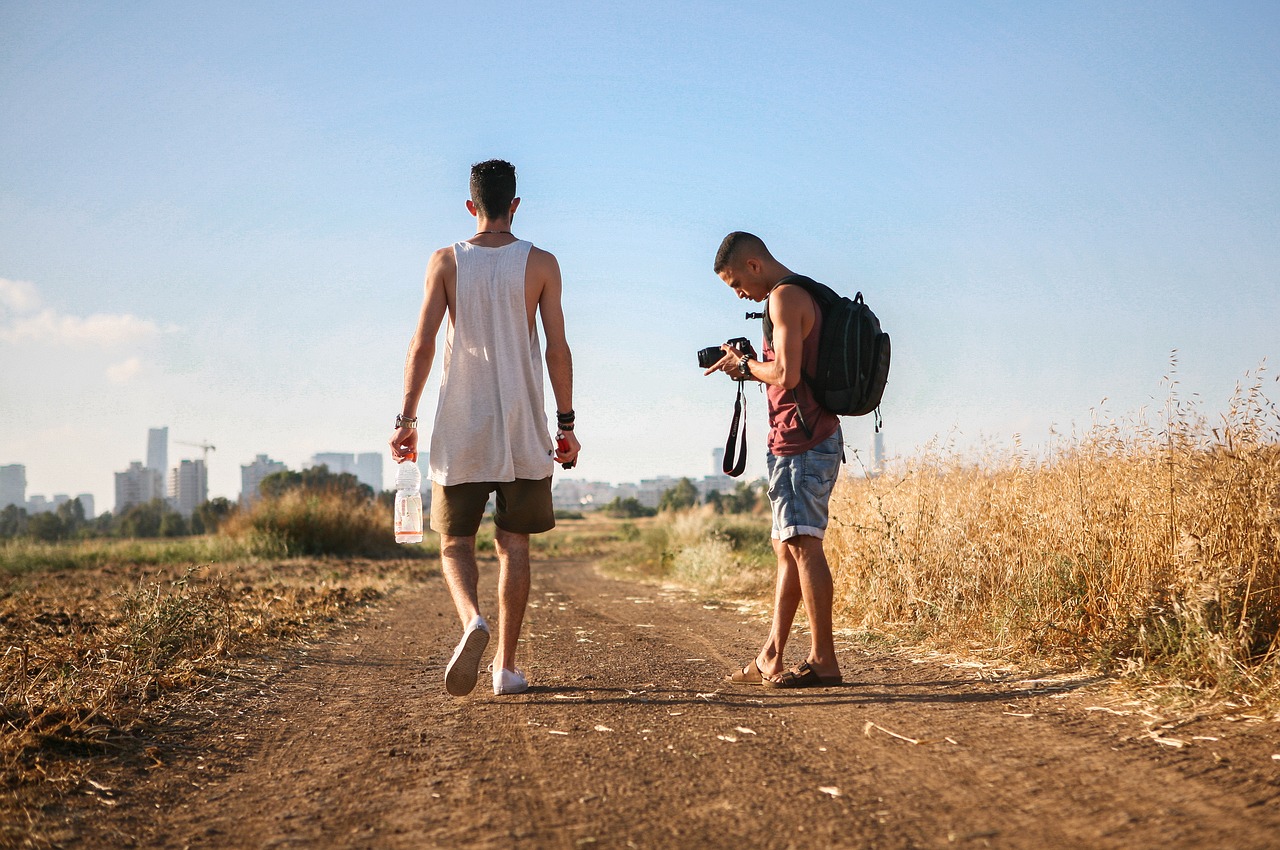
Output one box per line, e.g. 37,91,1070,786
764,274,890,430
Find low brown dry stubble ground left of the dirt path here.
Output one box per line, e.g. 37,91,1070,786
0,550,431,846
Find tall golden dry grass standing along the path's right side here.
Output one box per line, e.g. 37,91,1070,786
827,370,1280,696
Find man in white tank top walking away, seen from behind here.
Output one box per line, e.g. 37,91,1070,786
390,160,579,696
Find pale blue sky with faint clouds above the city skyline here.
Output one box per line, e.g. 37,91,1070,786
0,0,1280,512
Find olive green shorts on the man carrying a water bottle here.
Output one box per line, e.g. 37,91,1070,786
431,475,556,538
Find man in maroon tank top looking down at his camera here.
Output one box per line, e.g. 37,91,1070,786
705,230,844,687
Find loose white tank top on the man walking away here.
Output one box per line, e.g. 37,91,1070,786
430,241,553,485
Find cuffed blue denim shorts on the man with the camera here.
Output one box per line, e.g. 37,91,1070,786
768,428,845,540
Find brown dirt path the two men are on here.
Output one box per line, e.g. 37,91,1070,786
59,562,1280,850
